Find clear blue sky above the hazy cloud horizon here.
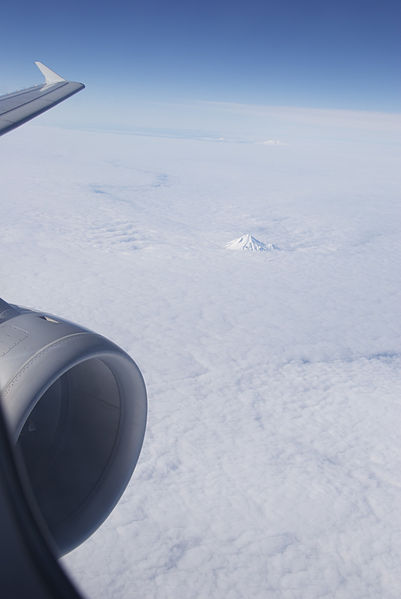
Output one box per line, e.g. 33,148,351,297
0,0,401,129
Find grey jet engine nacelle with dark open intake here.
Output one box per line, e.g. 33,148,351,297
0,300,147,555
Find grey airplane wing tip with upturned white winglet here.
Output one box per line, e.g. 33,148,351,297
0,62,85,135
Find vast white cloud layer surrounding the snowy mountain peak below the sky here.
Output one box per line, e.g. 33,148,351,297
0,122,401,599
